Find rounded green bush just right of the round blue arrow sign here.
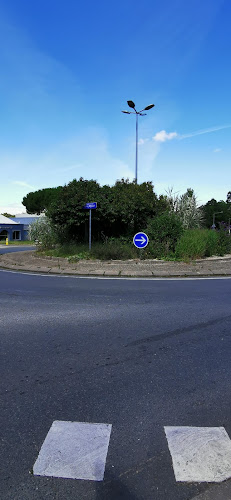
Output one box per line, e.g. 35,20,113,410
145,212,183,258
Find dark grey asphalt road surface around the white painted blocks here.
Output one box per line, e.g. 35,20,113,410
0,271,231,500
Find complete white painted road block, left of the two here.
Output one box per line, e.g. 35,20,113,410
33,420,112,481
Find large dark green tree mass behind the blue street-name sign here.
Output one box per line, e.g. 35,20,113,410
47,178,167,241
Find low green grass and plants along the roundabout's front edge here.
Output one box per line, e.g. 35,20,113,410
38,229,231,262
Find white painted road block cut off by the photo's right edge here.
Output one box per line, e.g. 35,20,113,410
164,427,231,483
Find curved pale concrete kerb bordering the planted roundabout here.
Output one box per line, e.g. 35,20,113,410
0,250,231,278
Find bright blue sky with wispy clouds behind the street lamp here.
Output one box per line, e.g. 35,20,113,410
0,0,231,214
